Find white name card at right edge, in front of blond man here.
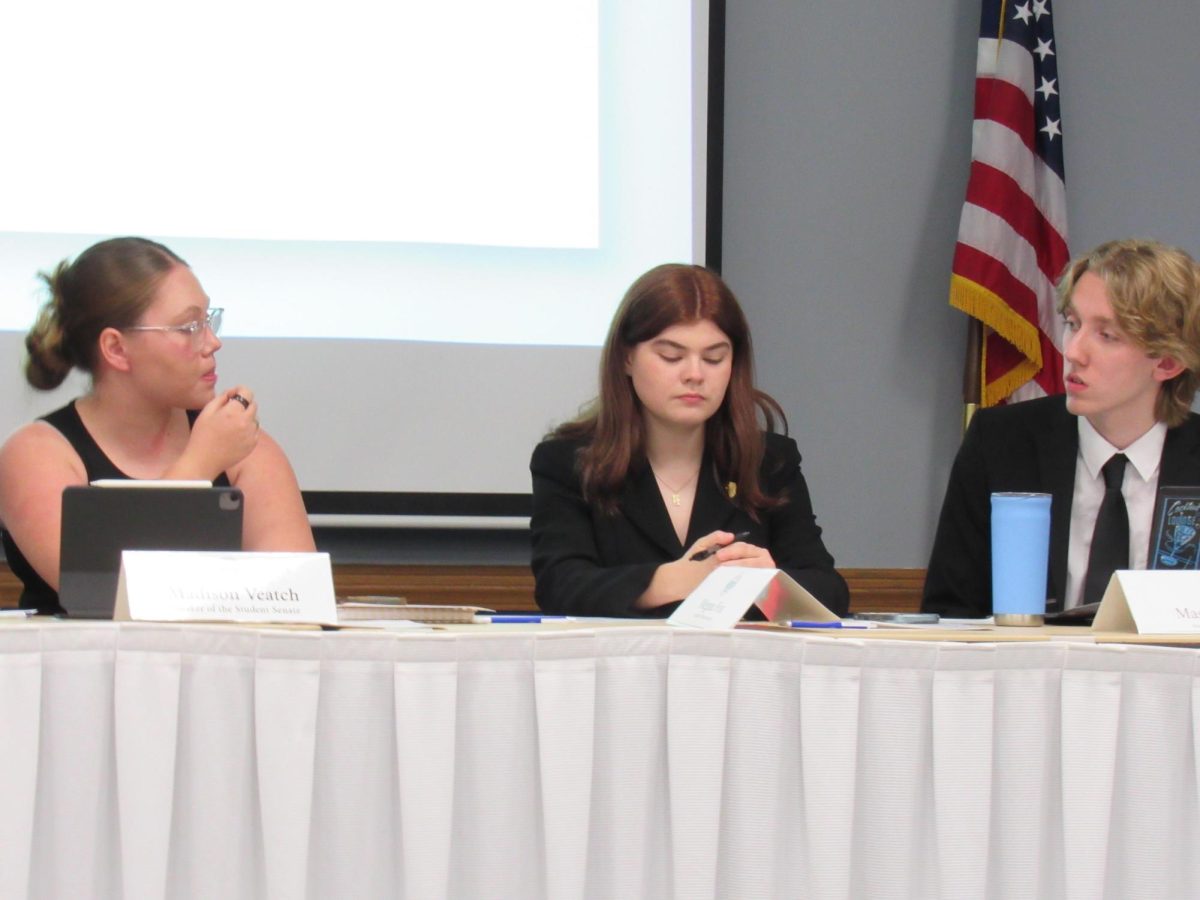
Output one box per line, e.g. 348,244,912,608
1092,569,1200,635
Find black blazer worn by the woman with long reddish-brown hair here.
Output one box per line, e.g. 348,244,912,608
529,434,850,618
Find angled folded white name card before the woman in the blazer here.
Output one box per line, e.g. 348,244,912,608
667,565,838,628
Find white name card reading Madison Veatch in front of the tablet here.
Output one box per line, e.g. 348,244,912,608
113,550,337,625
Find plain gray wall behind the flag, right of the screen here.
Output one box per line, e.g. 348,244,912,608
724,0,1200,568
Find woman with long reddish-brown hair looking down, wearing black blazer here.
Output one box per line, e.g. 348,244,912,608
529,264,850,617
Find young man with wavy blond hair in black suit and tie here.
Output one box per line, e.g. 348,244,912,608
922,240,1200,617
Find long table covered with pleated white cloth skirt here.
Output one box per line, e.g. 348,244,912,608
0,622,1200,900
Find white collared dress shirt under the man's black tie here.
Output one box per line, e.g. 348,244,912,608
1063,415,1166,608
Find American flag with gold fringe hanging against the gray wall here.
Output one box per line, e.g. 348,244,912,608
950,0,1070,407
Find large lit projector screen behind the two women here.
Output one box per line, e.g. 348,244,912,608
0,0,719,512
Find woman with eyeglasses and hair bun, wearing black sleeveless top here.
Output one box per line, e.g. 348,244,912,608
0,238,313,613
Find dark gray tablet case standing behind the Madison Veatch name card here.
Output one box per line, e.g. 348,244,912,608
59,481,242,619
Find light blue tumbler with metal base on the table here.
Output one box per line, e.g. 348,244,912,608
991,493,1050,625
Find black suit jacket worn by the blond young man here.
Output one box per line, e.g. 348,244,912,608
922,396,1200,618
